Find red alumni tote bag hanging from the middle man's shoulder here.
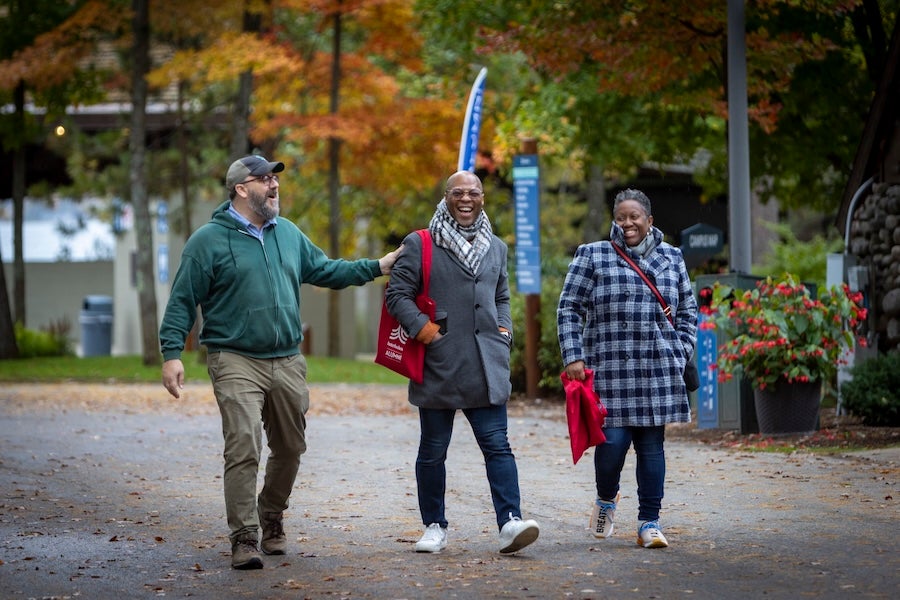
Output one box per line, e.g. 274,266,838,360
375,229,435,383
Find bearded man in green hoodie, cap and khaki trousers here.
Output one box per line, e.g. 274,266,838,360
159,155,402,569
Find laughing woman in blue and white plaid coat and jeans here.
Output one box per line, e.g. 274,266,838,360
557,189,697,548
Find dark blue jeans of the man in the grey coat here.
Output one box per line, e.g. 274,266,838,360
416,405,522,527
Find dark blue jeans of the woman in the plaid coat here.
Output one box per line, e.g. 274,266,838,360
594,425,666,521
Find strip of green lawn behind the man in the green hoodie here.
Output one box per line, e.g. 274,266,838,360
0,352,407,385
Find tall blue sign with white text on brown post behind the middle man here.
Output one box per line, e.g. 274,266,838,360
513,154,541,294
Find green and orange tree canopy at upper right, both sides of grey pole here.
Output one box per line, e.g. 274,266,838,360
474,0,897,216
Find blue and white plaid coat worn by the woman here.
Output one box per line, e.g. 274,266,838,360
557,226,697,427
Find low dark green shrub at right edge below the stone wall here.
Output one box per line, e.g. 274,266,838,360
841,351,900,427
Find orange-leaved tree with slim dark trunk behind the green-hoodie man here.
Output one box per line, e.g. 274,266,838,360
255,0,464,356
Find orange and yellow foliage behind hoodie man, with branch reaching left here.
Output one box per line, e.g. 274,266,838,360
151,0,460,255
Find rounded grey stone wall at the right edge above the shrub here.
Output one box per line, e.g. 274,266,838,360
850,183,900,352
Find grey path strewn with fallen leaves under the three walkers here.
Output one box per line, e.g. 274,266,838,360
0,384,900,599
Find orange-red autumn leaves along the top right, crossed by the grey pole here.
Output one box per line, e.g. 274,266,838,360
484,0,859,131
